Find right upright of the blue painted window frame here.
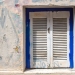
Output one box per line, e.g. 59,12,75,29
69,10,74,68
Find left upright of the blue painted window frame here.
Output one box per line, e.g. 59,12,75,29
26,11,30,68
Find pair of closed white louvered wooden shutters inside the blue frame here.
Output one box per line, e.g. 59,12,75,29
29,11,70,68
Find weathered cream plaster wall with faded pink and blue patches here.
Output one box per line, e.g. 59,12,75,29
0,0,75,71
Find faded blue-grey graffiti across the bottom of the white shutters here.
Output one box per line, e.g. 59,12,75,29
33,59,65,68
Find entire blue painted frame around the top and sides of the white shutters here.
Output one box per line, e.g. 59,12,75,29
26,8,74,68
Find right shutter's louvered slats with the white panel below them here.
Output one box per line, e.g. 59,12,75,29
53,18,67,67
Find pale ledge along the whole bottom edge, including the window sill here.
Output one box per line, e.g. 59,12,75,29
0,69,75,75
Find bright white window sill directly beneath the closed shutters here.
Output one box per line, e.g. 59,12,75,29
24,69,75,74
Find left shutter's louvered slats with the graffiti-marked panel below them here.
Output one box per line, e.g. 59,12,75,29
33,18,47,68
